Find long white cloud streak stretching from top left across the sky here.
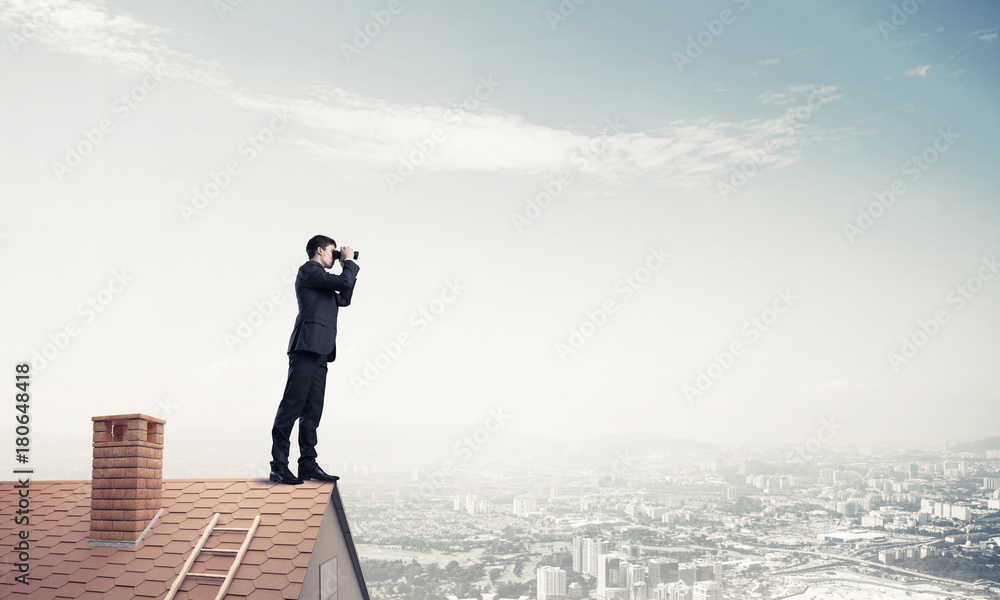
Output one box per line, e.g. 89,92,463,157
0,0,856,195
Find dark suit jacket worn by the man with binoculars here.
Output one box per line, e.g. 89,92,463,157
288,260,360,362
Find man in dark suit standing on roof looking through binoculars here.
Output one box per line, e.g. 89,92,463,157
270,235,359,485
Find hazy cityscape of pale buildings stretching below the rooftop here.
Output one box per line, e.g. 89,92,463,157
318,438,1000,600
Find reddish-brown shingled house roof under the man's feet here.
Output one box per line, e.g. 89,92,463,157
0,479,369,600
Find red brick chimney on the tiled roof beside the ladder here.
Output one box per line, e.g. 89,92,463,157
90,413,166,546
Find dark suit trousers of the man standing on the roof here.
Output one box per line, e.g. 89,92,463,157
271,350,327,469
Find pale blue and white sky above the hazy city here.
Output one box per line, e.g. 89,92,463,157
0,0,1000,478
